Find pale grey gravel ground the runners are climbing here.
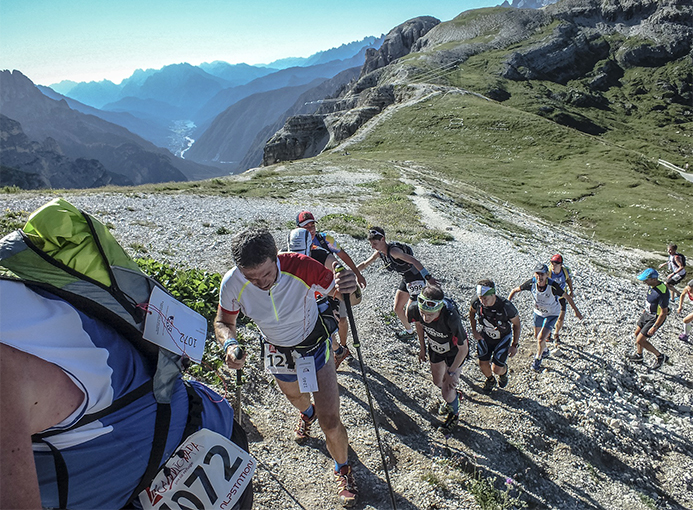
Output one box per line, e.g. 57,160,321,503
0,169,693,509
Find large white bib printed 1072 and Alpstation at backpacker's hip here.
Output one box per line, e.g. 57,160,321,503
139,429,257,510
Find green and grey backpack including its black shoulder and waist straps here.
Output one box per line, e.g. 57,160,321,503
0,198,201,508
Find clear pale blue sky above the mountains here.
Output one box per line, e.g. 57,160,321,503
0,0,502,85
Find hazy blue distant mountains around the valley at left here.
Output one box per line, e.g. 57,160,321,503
0,37,382,187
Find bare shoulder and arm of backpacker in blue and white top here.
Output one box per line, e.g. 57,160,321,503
0,344,84,509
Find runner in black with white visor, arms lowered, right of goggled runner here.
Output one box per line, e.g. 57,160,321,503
469,280,521,391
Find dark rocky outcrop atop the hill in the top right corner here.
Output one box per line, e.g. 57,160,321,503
500,0,693,82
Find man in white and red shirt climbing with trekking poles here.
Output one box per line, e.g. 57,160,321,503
214,228,358,506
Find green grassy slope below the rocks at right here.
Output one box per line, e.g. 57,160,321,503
334,8,693,250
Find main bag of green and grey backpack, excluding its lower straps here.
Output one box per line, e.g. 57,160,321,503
0,198,172,366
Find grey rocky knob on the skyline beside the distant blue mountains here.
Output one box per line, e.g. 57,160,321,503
361,16,440,76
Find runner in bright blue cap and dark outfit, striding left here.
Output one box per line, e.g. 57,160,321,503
626,267,669,369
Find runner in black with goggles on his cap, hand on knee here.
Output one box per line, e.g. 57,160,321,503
407,283,469,433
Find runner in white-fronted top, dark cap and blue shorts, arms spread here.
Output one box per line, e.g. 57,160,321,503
508,264,582,372
